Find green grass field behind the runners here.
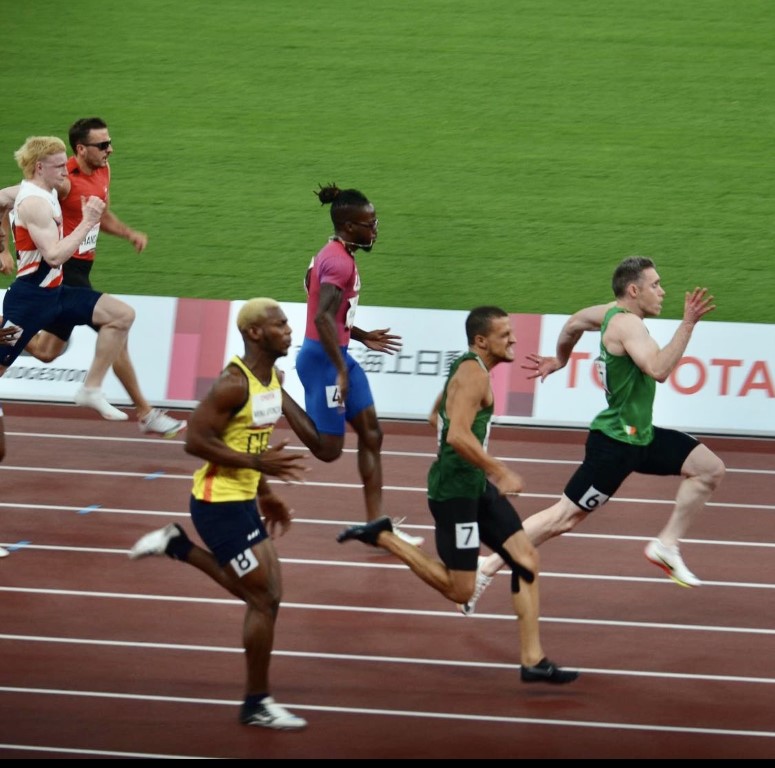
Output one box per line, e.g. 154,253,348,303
0,0,775,323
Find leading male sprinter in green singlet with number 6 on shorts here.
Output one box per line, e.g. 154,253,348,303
461,256,725,615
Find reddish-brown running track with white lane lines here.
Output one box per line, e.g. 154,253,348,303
0,404,775,759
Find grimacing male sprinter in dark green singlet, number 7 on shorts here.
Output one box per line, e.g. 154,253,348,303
337,306,578,684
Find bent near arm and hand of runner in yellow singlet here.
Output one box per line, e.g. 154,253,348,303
185,367,304,480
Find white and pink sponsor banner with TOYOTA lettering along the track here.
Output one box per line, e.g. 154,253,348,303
0,296,775,436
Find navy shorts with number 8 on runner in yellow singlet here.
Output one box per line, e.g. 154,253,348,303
189,496,269,576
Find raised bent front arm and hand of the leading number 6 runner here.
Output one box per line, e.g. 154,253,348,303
606,288,716,382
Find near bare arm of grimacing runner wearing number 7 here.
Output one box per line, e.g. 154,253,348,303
446,360,524,494
